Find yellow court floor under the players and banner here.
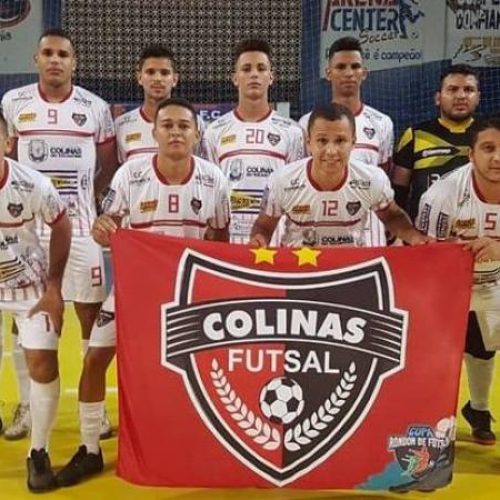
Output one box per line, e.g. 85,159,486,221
0,308,500,500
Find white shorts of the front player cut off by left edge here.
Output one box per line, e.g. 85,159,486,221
0,299,59,351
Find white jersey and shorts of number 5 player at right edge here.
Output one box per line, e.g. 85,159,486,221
417,163,500,350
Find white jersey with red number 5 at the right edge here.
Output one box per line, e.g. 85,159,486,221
416,163,500,285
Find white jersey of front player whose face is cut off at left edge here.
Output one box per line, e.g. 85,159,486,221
0,159,65,301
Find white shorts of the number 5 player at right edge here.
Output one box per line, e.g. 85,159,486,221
470,285,500,351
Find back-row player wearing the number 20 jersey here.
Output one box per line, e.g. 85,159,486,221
206,39,305,245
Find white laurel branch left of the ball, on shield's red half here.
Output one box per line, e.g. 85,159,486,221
210,359,281,450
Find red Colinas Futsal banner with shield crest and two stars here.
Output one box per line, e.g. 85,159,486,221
112,230,472,491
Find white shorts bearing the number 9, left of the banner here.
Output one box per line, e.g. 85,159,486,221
41,236,106,303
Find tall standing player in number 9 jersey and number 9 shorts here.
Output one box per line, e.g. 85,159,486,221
2,29,117,439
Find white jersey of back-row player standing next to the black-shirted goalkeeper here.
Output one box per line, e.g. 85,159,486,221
299,104,394,166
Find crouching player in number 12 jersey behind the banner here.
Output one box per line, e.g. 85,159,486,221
251,103,430,247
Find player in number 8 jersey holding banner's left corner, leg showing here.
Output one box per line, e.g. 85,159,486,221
57,98,230,486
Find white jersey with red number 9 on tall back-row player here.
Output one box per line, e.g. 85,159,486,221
2,84,115,236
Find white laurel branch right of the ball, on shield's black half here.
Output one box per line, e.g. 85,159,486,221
284,362,358,451
